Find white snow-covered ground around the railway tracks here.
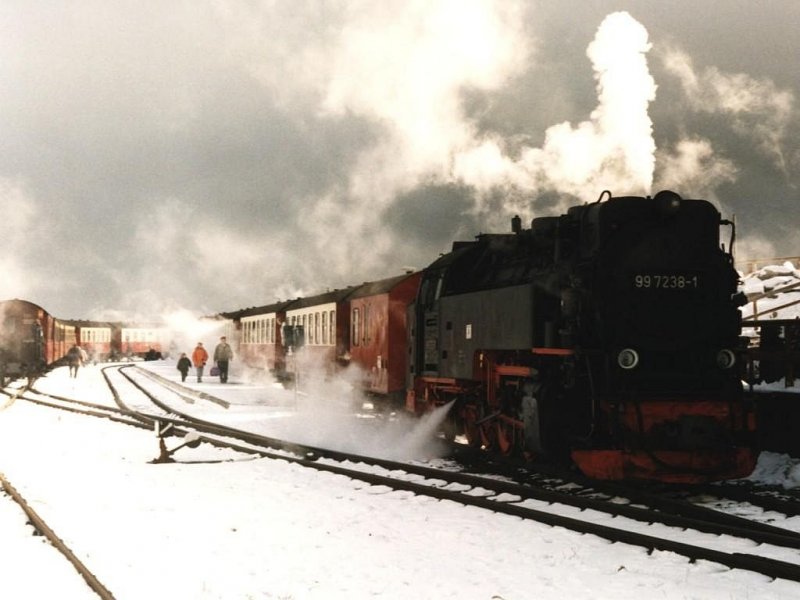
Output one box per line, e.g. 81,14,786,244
0,361,800,600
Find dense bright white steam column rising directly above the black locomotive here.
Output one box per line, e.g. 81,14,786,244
455,12,656,218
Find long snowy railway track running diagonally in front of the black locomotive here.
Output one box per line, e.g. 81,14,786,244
10,369,800,582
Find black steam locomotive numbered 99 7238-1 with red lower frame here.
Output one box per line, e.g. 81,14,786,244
406,191,756,482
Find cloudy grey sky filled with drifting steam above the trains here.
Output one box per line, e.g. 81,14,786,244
0,0,800,319
